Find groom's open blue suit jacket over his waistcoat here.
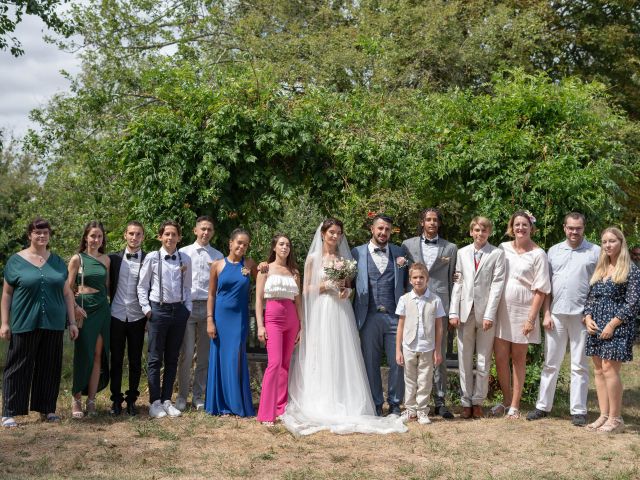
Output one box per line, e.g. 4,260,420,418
351,243,408,330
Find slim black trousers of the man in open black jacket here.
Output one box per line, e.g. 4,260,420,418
111,317,147,403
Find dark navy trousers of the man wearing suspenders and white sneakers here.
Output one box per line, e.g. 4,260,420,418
147,302,190,403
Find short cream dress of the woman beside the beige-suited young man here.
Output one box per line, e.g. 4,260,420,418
496,242,551,343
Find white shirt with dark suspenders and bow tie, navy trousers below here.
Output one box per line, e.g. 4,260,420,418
138,247,193,315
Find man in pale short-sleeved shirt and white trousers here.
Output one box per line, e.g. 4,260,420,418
527,212,600,427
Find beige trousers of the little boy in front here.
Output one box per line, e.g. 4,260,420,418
402,346,433,413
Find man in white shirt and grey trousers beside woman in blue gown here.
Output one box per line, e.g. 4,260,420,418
176,215,224,411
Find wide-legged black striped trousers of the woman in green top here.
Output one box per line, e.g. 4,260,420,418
2,329,64,417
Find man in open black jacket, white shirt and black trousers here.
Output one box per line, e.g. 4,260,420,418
109,221,147,416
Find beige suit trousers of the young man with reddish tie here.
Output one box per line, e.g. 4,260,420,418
458,309,496,407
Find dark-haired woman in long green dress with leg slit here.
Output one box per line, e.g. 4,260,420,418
69,221,111,418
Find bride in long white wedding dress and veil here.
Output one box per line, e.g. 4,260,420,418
281,218,407,435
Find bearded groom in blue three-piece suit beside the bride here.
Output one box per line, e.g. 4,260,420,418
351,215,407,416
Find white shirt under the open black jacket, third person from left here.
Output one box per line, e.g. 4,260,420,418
111,248,144,322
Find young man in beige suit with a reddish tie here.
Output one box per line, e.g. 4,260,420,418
449,217,505,418
